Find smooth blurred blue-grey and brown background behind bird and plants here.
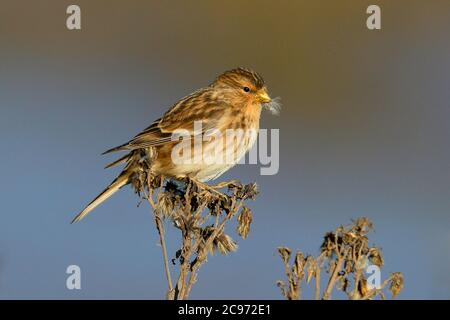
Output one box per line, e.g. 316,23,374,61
0,0,450,299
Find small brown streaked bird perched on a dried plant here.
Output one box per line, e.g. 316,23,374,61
72,68,279,222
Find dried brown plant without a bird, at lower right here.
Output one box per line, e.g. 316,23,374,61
277,218,403,300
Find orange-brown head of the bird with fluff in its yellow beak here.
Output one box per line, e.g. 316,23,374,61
211,68,280,114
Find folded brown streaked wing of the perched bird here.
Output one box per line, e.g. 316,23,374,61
104,88,229,154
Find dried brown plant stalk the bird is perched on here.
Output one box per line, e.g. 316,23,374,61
133,170,258,300
